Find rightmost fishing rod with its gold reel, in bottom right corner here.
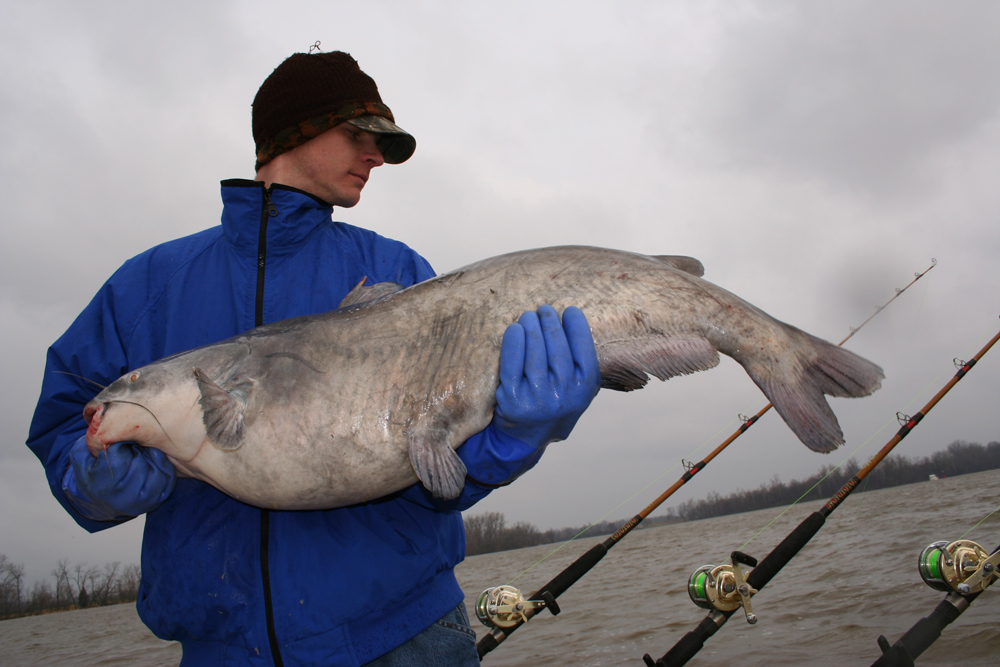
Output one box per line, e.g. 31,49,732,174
872,540,1000,667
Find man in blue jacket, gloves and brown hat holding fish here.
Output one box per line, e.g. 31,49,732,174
28,52,600,667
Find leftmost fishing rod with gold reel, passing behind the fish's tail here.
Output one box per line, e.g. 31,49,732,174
476,258,937,661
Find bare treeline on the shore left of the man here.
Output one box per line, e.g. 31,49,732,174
0,554,139,619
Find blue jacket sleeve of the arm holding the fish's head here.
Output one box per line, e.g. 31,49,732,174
27,281,135,533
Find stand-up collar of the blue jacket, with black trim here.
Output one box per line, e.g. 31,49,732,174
222,178,333,250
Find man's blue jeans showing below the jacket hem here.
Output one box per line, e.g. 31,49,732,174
364,603,479,667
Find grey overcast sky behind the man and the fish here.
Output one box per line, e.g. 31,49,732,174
0,0,1000,578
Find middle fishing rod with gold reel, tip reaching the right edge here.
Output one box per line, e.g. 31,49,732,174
642,324,1000,667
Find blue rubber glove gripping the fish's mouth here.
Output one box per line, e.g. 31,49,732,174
62,436,177,521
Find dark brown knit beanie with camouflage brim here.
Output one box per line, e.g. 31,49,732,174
253,51,417,169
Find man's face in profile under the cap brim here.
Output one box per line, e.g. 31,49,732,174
288,123,385,208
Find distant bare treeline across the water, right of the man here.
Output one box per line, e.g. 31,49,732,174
464,440,1000,556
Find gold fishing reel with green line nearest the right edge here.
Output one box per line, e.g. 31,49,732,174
917,540,1000,595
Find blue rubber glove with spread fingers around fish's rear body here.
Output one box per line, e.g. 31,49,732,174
492,306,601,449
